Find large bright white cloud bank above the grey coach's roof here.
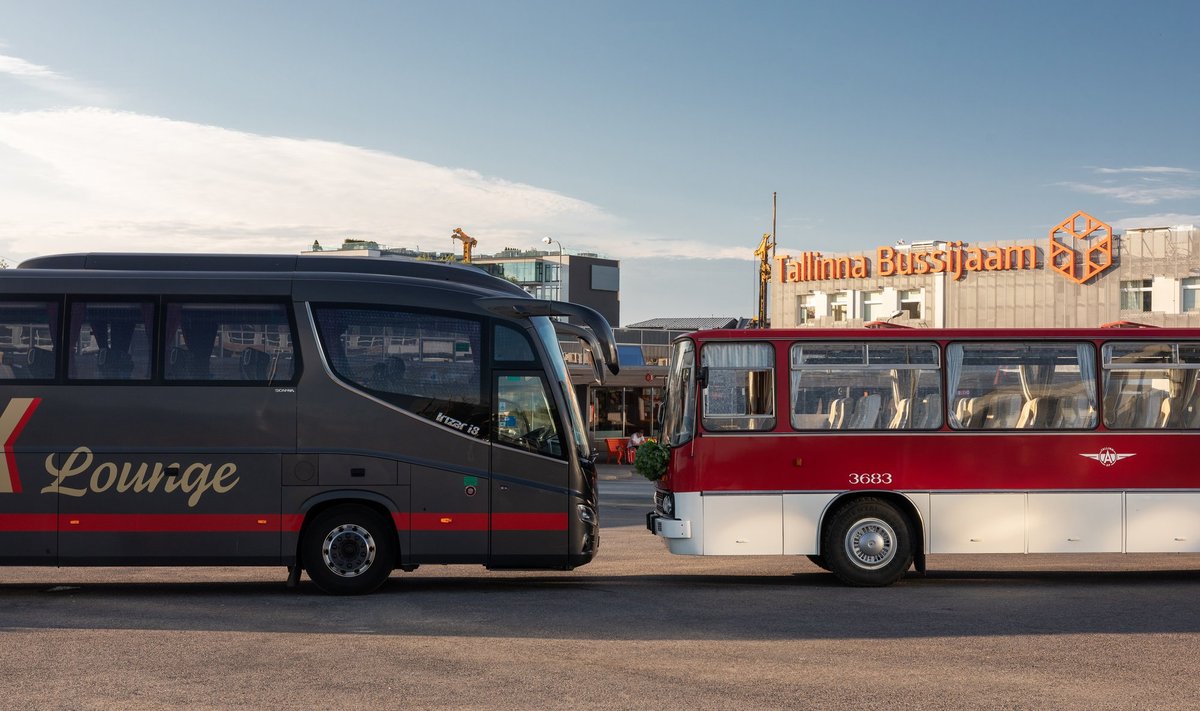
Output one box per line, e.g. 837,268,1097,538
0,108,751,265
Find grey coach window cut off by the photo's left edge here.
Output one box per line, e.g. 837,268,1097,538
0,301,59,381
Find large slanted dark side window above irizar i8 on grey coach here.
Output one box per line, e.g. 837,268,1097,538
313,306,490,437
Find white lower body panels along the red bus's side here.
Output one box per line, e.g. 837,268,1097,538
655,491,1200,555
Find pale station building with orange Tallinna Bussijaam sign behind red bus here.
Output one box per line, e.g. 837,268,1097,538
770,213,1200,328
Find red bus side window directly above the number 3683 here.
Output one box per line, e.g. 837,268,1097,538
790,342,943,430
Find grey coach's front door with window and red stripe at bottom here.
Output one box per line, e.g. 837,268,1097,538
491,370,569,567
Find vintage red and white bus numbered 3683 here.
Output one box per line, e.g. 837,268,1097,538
647,328,1200,586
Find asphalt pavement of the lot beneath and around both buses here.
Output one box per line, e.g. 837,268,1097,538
0,465,1200,711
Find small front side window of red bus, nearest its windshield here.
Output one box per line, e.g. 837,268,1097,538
700,343,775,430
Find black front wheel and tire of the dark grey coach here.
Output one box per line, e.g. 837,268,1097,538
300,504,397,595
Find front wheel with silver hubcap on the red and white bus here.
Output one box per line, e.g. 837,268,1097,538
821,498,913,587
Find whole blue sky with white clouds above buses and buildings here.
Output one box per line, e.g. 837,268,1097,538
0,0,1200,323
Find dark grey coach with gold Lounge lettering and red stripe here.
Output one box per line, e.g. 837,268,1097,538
0,253,618,593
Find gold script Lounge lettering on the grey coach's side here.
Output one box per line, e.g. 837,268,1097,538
42,447,241,508
